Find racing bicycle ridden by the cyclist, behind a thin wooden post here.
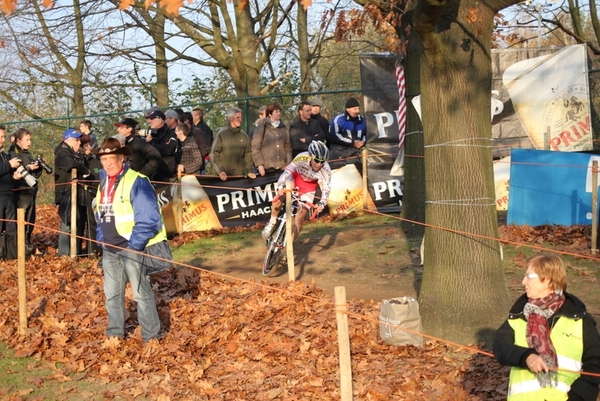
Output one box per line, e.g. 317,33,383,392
263,188,318,276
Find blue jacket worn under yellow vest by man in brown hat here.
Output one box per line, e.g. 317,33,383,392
96,164,163,251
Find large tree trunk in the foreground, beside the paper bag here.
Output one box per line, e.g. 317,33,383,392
415,1,510,343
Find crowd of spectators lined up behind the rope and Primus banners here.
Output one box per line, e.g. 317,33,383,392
0,97,366,255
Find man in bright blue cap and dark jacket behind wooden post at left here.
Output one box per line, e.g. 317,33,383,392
54,128,90,256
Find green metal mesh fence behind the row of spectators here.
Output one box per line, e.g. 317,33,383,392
3,89,361,204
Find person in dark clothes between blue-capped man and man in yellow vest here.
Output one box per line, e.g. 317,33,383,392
78,135,102,255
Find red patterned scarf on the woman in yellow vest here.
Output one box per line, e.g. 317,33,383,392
523,292,565,387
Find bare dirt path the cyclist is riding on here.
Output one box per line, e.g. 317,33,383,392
197,223,422,301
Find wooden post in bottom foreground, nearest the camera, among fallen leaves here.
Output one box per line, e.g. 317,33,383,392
334,287,352,401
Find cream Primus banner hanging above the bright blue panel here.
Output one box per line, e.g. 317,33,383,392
492,45,592,155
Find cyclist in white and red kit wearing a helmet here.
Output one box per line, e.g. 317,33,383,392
262,141,331,240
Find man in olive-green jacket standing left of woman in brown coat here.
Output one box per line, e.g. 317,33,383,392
210,108,256,181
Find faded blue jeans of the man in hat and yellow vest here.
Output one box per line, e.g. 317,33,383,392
102,248,160,341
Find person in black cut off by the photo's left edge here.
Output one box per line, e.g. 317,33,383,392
0,125,21,234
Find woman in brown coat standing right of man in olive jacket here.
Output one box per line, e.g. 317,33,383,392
252,104,292,176
